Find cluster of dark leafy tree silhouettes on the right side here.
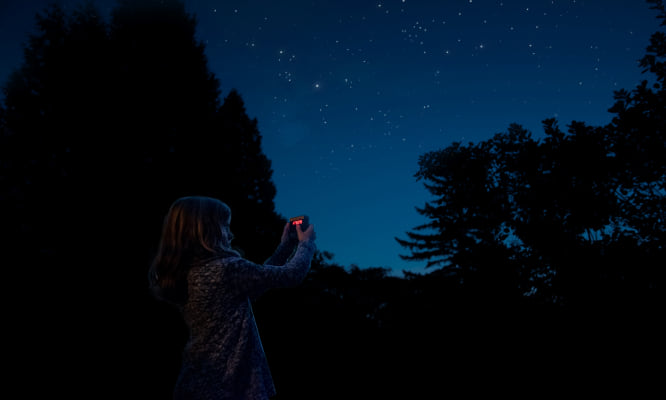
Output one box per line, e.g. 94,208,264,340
396,0,666,307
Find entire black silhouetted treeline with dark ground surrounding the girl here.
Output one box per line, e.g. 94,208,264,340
0,0,666,399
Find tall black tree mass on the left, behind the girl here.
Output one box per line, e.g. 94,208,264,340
0,0,285,397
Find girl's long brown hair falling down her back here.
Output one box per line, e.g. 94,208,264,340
148,196,238,305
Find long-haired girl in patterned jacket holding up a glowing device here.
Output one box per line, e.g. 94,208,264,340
149,196,316,400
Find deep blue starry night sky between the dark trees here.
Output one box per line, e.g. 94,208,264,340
0,0,659,274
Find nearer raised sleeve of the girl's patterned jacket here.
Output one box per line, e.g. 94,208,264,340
224,241,316,298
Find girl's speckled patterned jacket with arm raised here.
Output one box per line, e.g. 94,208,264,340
174,241,316,400
